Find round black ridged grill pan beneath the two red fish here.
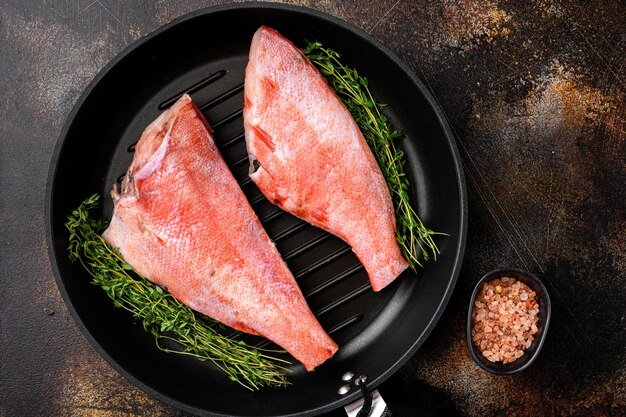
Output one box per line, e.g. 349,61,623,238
47,3,467,416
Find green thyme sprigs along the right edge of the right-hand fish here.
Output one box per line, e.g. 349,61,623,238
302,42,442,270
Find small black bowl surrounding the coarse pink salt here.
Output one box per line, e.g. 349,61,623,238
467,269,552,375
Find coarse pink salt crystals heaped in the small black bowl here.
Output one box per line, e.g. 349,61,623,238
471,277,539,364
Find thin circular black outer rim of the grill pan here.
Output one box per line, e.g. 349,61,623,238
45,2,468,417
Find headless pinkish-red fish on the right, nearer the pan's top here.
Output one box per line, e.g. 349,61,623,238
243,26,408,291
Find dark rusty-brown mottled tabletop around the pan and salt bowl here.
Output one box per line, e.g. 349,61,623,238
0,0,626,417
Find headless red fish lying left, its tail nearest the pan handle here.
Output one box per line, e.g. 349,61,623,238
103,95,337,370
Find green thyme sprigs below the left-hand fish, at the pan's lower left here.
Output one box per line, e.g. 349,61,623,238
65,194,289,390
